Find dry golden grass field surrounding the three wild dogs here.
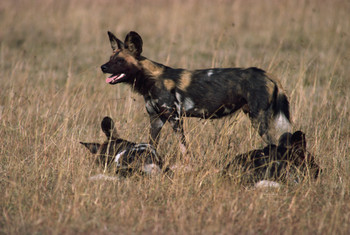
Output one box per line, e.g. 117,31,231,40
0,0,350,234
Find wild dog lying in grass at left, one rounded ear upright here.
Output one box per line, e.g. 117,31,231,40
80,117,162,175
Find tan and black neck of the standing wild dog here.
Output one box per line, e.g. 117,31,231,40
131,57,167,95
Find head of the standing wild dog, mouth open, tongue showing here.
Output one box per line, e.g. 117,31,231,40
101,31,143,85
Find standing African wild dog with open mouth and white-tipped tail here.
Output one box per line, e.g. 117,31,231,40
101,32,290,156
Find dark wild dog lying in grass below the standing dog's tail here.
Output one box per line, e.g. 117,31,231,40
223,131,320,183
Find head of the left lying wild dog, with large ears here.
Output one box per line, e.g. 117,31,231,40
80,117,124,165
